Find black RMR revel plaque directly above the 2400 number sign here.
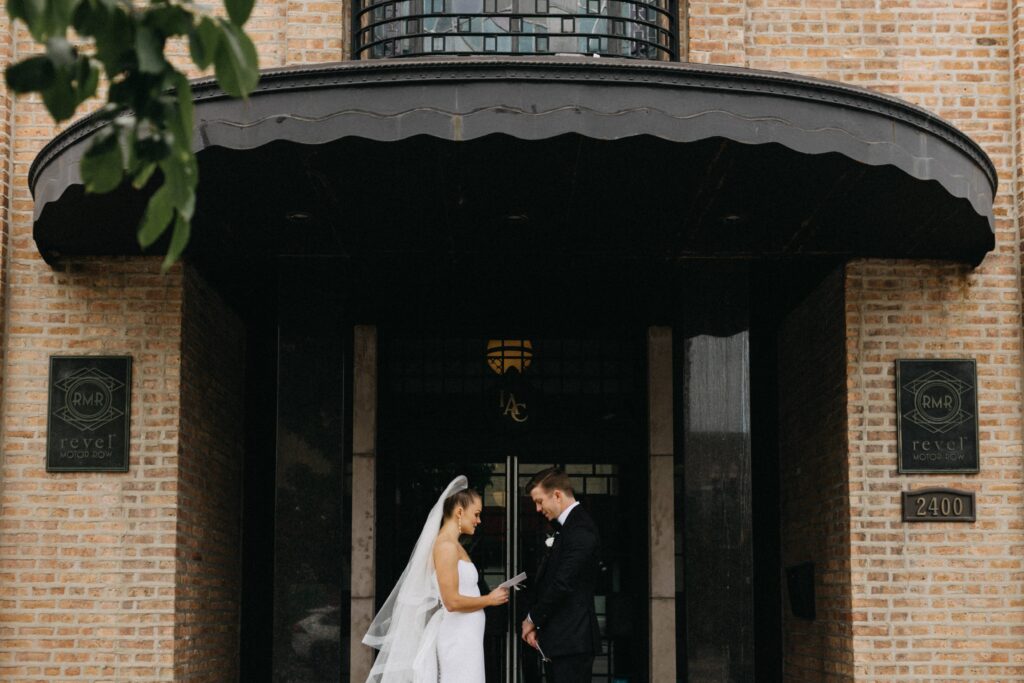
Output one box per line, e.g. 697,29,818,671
896,358,978,473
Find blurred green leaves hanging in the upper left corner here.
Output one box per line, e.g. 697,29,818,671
6,0,259,270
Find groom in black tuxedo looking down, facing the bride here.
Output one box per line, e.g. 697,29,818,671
522,467,601,683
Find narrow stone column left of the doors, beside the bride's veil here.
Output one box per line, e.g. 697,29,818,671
349,325,377,681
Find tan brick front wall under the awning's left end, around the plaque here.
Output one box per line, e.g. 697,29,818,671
0,259,181,683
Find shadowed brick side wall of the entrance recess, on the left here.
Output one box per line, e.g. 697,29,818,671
174,268,245,683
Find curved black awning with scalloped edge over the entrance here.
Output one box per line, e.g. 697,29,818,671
30,57,996,263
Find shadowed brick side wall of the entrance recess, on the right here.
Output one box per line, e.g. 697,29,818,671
778,269,853,681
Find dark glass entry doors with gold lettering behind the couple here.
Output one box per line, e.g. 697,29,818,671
376,330,649,683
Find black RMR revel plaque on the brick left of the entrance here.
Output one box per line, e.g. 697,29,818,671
46,355,131,472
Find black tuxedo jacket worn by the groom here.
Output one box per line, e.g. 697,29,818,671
528,505,601,657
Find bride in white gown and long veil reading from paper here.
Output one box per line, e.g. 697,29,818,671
362,476,509,683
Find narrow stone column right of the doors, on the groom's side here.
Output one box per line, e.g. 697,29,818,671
647,327,676,681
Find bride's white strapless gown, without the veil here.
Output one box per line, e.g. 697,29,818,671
437,560,487,683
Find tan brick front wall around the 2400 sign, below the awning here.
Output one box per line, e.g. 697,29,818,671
846,260,1024,681
